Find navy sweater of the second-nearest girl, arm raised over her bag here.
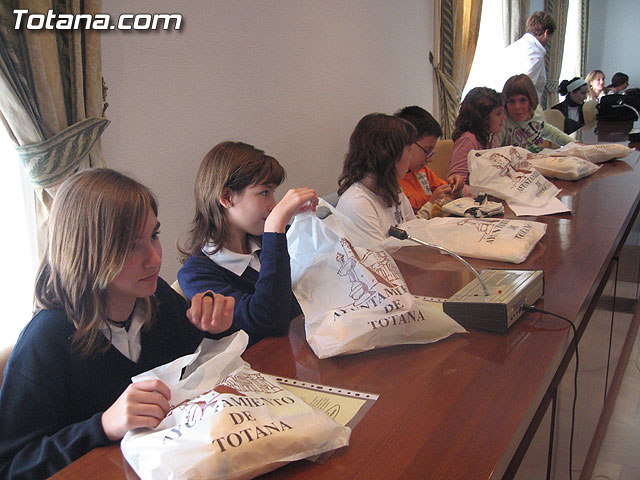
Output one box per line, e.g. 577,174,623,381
178,232,302,345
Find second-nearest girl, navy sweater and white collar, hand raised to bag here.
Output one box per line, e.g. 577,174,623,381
178,141,318,344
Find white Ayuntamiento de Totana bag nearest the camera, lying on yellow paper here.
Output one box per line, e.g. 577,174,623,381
121,331,351,480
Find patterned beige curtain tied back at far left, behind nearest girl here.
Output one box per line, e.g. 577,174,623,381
0,0,109,254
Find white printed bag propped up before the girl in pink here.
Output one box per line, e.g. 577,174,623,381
467,147,560,207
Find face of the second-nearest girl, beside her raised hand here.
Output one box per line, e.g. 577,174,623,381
223,184,276,236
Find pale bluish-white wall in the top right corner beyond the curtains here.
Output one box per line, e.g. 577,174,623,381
587,0,640,87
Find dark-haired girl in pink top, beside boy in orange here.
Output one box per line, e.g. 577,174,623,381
448,87,508,183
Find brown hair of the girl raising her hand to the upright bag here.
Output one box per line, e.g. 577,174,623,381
178,141,285,263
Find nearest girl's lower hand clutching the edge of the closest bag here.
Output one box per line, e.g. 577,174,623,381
102,380,171,441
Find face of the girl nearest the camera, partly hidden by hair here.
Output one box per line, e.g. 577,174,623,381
107,209,162,312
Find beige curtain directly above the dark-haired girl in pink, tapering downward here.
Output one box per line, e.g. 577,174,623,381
429,0,482,138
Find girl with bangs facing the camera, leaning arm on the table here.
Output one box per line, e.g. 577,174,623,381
498,73,575,153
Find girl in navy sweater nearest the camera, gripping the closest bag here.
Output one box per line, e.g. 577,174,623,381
0,169,233,478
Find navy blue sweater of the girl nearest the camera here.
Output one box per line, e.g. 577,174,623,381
0,279,205,479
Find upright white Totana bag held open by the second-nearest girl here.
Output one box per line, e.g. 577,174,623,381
287,202,465,358
